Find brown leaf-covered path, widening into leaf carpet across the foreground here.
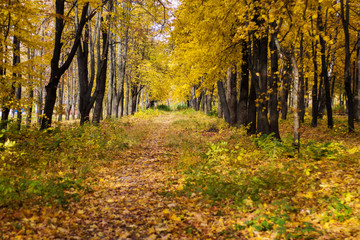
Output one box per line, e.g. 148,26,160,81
0,114,245,239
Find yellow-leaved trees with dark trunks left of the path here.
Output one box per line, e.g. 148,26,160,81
0,0,170,129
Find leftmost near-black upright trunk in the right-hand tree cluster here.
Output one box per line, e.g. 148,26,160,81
238,40,250,127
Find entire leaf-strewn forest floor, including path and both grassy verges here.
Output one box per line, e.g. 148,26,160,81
0,110,360,239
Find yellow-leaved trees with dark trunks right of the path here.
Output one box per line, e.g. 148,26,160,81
172,0,360,135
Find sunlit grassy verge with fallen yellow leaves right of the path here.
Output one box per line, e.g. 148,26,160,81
169,112,360,239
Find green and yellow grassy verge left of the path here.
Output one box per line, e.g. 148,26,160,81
0,120,142,206
